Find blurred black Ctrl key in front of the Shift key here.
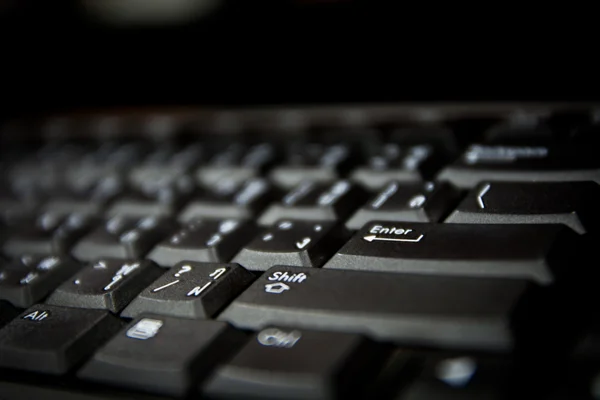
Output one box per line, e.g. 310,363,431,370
204,327,382,399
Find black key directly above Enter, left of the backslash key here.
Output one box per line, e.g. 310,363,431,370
346,181,459,230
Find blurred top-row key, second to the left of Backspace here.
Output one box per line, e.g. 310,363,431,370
269,143,352,190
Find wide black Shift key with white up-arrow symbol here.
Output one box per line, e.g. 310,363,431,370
218,267,535,351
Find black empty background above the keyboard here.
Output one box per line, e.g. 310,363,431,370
0,0,599,117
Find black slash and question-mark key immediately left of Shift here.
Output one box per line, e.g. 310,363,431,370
121,261,254,318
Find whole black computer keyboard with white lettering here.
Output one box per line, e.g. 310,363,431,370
0,104,600,400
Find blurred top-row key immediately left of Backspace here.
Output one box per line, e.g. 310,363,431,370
351,143,440,190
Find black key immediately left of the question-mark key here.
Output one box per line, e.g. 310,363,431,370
46,258,162,313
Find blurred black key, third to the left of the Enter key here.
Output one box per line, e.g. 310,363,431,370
72,216,176,261
